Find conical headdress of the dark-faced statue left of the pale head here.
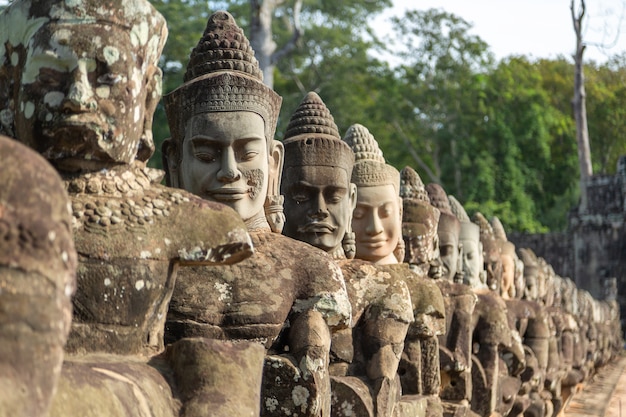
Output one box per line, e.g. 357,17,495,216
283,92,354,174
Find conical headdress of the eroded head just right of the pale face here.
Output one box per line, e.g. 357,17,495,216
400,166,440,240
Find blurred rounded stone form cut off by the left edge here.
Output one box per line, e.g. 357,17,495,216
0,136,76,417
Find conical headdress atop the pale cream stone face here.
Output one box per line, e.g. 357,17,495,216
343,123,400,193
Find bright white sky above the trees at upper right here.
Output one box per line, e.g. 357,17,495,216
376,0,626,62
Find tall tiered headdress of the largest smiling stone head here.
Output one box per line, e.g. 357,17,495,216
164,11,282,143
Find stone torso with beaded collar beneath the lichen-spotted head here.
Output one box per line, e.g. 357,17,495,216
66,162,249,354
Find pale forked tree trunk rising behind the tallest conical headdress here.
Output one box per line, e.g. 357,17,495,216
250,0,302,88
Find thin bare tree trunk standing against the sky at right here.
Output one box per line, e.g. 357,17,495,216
570,0,593,213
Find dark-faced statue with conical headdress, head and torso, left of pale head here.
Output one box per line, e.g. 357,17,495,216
283,99,413,417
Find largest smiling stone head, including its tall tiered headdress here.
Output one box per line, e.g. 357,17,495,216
163,11,283,229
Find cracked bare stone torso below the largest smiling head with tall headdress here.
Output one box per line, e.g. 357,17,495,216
166,231,350,353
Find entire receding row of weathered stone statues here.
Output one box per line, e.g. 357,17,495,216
0,0,621,417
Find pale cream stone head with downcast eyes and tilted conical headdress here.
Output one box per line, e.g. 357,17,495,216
343,124,402,265
